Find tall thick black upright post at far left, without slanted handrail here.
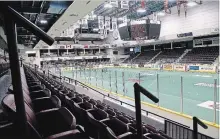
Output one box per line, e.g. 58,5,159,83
4,11,28,139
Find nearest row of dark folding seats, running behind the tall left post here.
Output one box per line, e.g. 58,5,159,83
0,68,87,139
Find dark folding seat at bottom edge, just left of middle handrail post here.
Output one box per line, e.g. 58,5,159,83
100,118,134,139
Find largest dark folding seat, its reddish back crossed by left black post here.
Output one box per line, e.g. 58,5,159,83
2,94,80,137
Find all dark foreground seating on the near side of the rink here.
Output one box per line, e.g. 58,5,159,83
0,67,174,139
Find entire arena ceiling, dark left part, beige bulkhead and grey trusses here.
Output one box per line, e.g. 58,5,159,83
0,0,195,48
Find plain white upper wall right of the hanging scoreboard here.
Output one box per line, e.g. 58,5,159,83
157,1,219,39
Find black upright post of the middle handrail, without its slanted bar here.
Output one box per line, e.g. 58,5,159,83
134,86,142,139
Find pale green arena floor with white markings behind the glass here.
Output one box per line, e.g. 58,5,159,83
62,68,219,124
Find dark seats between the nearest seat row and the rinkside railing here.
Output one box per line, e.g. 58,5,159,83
25,65,170,139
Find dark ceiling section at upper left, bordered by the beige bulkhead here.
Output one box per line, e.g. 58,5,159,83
1,1,72,47
